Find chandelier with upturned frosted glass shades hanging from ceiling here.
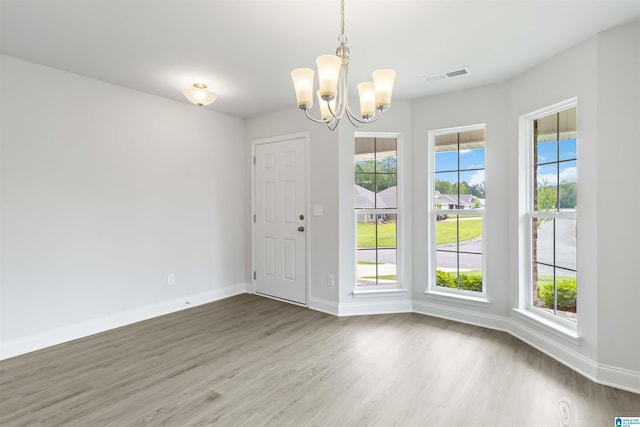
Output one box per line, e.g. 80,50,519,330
291,0,396,130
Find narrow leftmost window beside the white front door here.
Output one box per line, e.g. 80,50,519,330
354,137,398,286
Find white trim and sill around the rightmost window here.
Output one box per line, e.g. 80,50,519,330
514,98,580,334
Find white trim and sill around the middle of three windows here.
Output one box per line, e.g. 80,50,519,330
424,123,489,307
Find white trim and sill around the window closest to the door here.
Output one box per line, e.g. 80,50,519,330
352,132,407,297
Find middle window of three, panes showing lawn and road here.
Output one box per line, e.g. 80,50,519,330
430,126,485,295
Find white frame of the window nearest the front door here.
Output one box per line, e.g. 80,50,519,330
352,132,405,290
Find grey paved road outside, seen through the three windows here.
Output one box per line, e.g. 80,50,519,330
357,220,576,276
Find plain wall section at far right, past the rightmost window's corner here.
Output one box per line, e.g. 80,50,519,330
596,21,640,374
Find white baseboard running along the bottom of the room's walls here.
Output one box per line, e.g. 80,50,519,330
0,290,640,394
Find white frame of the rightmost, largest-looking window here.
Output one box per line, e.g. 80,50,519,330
517,97,580,332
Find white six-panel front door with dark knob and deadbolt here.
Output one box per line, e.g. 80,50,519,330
254,138,307,304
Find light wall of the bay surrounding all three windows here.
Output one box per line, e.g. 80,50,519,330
248,22,640,391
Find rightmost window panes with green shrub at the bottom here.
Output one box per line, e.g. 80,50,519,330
529,103,578,322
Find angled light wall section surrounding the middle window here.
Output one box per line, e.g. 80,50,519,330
413,84,510,322
